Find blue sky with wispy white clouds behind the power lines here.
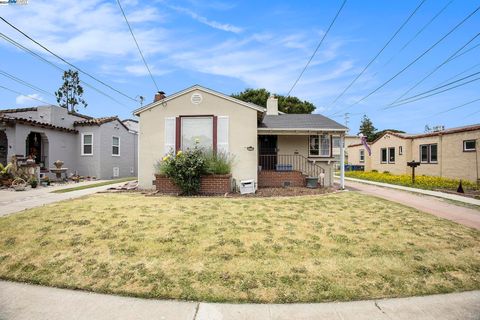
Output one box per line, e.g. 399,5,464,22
0,0,480,134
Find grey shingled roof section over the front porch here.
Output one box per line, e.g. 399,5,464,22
258,114,348,131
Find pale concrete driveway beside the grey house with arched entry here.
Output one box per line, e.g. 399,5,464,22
0,180,126,216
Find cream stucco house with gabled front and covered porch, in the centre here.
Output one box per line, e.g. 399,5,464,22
134,85,347,189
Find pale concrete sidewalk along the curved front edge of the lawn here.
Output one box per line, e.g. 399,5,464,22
0,281,480,320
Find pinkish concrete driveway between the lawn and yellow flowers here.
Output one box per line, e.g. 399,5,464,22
345,180,480,230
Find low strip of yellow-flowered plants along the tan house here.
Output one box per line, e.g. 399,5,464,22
345,171,479,190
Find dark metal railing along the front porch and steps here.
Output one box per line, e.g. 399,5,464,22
258,154,325,177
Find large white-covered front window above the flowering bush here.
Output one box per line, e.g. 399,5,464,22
181,117,213,150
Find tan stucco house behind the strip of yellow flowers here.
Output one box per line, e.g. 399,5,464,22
348,124,480,181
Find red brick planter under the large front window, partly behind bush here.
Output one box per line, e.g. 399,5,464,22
153,174,232,195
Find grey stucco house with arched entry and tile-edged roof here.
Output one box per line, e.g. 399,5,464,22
0,106,138,179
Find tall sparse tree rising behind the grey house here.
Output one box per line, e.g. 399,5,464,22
55,70,87,112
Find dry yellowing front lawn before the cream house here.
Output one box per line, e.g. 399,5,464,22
0,192,480,303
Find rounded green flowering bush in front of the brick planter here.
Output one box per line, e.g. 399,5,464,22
157,147,207,195
